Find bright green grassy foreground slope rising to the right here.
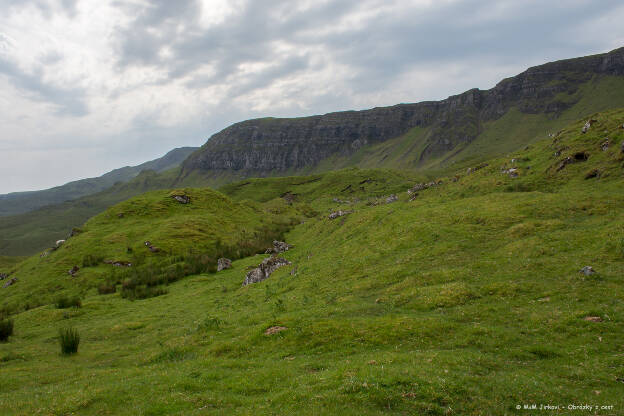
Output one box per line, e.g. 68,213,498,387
0,111,624,415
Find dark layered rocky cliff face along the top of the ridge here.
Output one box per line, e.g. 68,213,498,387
182,48,624,177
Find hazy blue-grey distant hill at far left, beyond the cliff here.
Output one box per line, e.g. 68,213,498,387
0,147,197,216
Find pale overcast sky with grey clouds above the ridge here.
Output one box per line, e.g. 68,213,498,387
0,0,624,193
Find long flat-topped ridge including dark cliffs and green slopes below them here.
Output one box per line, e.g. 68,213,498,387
181,48,624,185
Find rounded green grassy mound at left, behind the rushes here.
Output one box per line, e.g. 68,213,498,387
2,188,298,310
